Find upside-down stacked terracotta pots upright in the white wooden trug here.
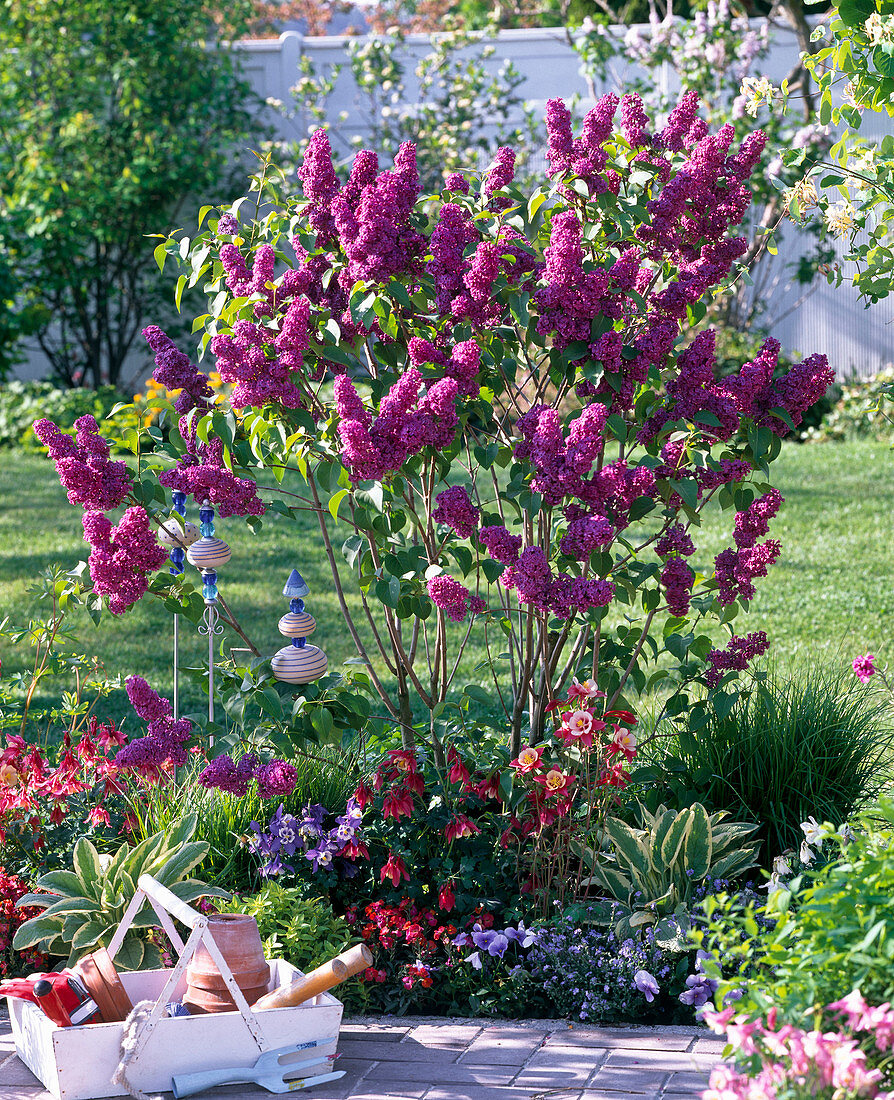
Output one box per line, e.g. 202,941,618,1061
184,913,271,1014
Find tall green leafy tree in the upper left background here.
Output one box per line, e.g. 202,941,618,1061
0,0,258,386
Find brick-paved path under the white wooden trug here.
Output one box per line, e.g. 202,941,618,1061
0,1013,722,1100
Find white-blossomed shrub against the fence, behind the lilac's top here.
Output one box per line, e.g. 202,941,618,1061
277,26,538,194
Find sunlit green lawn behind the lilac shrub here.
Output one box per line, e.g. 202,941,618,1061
0,442,894,730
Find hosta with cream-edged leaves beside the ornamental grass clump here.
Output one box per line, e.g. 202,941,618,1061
580,802,758,944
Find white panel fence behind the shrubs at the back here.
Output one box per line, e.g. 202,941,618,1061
13,28,894,377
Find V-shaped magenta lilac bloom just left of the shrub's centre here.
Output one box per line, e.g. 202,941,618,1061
335,366,459,482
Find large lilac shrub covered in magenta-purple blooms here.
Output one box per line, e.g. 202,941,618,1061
33,92,832,768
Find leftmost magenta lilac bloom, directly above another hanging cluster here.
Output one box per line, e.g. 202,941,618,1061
34,414,131,512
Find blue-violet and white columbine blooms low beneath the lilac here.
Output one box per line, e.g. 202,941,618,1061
244,798,369,878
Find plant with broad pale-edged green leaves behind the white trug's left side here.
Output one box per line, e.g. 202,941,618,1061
12,814,229,970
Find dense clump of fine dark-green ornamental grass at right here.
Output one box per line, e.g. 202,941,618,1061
638,666,894,867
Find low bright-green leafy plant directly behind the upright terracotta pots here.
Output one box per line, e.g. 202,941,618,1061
218,881,356,974
